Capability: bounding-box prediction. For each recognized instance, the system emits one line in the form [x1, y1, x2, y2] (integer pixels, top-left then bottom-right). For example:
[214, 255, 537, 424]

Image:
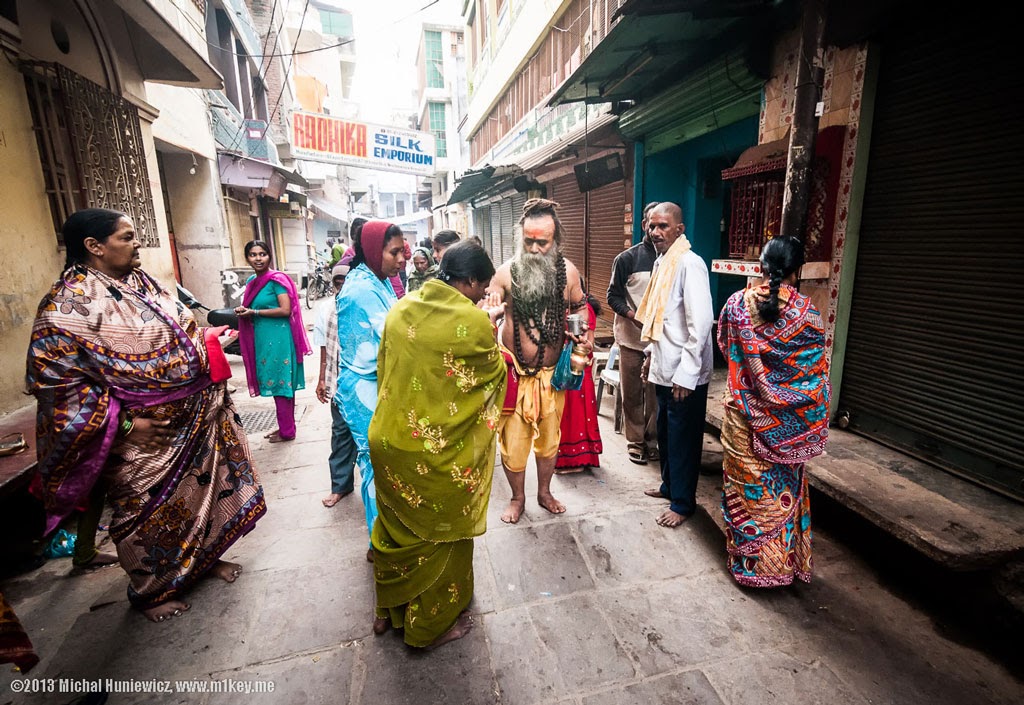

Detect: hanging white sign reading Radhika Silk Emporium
[292, 111, 436, 175]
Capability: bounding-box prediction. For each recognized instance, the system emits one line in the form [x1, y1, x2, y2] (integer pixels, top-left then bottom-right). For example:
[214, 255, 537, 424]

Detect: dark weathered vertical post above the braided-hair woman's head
[779, 0, 827, 240]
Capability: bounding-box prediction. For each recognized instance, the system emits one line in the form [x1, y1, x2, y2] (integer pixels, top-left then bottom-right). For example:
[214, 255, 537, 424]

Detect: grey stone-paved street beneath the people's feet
[0, 363, 1024, 705]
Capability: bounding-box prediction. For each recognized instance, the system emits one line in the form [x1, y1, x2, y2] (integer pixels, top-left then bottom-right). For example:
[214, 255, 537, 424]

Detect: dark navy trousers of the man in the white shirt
[655, 384, 708, 516]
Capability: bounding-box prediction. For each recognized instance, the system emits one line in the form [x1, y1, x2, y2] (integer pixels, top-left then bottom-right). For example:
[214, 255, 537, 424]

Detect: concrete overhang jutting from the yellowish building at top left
[113, 0, 224, 89]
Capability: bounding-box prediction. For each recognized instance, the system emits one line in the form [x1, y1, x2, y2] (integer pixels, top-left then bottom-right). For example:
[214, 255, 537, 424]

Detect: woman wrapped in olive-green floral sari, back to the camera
[370, 242, 507, 647]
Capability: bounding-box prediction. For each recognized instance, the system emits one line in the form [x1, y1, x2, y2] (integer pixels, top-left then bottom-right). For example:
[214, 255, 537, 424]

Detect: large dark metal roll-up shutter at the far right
[838, 13, 1024, 499]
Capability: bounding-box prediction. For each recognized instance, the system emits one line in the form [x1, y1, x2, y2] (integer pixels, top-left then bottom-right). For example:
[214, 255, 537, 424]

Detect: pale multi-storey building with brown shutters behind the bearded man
[450, 0, 633, 320]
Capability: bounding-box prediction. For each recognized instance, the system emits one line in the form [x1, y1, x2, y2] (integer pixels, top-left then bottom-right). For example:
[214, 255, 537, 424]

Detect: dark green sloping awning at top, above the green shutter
[548, 0, 792, 106]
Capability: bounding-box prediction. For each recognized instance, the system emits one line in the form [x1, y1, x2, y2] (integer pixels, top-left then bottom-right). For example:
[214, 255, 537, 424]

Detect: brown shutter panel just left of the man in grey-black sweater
[585, 181, 629, 321]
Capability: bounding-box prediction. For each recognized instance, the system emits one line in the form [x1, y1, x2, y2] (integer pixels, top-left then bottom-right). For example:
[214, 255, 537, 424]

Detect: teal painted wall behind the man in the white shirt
[634, 116, 758, 314]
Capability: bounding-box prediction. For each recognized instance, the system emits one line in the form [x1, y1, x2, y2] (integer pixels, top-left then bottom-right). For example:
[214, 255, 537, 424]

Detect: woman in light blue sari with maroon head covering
[335, 220, 406, 561]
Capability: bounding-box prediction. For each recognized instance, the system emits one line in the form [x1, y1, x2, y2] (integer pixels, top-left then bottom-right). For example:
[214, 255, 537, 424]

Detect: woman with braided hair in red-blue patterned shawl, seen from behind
[718, 238, 831, 587]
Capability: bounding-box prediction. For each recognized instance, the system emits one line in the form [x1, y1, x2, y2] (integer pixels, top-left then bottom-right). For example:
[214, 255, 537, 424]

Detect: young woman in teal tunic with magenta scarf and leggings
[234, 240, 312, 443]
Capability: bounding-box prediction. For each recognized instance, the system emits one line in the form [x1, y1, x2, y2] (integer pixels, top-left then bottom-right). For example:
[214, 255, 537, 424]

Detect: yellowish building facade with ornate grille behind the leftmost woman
[0, 0, 223, 414]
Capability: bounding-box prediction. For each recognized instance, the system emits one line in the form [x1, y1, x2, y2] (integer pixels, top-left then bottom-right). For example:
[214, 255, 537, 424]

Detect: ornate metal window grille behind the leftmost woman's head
[22, 61, 160, 247]
